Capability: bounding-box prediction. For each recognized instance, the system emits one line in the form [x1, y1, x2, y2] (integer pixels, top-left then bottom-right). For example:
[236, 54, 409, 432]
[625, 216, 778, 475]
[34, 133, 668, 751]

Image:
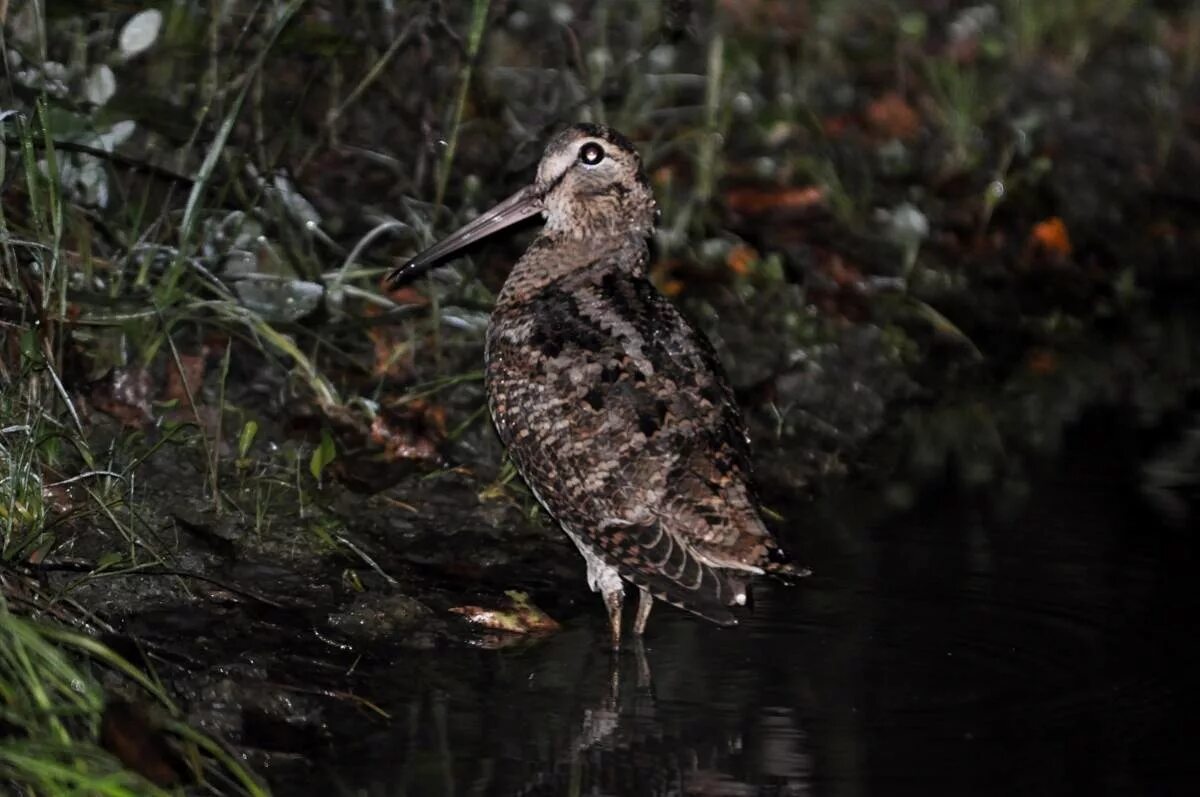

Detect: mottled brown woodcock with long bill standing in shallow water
[389, 125, 806, 648]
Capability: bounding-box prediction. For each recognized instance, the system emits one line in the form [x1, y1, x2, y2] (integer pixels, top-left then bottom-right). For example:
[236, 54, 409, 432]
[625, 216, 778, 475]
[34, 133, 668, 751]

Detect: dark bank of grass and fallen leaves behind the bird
[0, 0, 1200, 795]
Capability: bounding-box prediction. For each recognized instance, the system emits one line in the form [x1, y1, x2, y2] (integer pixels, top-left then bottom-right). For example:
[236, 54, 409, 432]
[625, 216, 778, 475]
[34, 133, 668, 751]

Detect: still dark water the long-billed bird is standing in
[295, 424, 1200, 795]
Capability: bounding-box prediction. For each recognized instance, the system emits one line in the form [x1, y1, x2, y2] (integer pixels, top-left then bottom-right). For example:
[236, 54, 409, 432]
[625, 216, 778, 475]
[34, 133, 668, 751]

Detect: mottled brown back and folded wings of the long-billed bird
[487, 262, 775, 622]
